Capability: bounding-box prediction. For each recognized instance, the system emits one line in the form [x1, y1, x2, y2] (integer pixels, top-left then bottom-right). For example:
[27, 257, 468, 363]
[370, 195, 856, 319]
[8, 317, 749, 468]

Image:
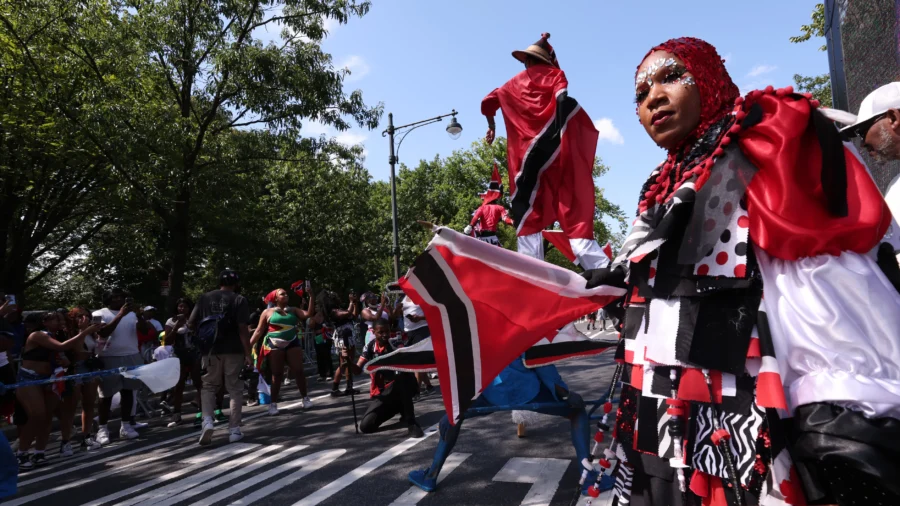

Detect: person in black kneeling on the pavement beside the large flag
[354, 319, 424, 437]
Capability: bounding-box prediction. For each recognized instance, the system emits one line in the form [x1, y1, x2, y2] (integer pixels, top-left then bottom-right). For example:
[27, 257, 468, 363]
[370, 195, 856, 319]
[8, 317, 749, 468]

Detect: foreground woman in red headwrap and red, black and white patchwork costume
[586, 38, 900, 505]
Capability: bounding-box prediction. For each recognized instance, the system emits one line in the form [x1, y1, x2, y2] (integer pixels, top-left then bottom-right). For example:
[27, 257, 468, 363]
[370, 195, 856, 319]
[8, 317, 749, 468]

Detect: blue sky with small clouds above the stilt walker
[286, 0, 828, 214]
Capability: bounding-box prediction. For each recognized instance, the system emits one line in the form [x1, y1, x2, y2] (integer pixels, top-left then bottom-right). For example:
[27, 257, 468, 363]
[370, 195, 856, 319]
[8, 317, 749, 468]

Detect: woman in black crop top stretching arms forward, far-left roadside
[16, 312, 100, 470]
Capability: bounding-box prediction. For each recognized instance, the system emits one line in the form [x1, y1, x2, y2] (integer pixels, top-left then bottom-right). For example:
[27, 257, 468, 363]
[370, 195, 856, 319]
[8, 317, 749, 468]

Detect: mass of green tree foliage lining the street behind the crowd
[0, 0, 625, 311]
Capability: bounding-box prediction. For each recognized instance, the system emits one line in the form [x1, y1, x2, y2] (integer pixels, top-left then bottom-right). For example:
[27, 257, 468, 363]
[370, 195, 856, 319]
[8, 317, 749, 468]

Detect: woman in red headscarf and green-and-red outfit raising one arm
[250, 288, 316, 415]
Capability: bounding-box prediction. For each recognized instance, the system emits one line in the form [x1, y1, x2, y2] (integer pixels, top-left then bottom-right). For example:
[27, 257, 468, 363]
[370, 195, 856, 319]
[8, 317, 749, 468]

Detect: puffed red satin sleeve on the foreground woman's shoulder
[738, 95, 891, 260]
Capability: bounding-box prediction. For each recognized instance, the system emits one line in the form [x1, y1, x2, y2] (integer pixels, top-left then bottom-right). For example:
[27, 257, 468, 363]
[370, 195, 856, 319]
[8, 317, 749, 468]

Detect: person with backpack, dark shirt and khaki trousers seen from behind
[188, 269, 253, 445]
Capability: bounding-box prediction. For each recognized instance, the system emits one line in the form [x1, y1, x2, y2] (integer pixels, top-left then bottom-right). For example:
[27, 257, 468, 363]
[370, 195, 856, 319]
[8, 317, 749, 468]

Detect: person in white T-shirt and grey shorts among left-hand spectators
[93, 288, 147, 445]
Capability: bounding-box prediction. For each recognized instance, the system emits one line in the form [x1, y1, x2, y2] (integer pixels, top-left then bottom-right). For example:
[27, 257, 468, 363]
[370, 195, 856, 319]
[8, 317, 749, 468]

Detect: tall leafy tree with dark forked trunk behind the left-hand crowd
[0, 0, 381, 310]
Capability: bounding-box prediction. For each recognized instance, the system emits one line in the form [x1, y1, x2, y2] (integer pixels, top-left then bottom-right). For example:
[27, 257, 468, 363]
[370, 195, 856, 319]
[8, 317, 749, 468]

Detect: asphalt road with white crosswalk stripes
[10, 324, 614, 506]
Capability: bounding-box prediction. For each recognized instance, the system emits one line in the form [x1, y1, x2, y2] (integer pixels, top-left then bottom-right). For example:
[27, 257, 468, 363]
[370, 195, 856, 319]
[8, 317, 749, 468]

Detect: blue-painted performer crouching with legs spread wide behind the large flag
[409, 359, 612, 492]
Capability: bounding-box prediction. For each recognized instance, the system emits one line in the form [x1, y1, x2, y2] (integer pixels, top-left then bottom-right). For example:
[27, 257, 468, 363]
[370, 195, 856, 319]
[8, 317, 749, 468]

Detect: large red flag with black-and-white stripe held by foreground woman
[400, 227, 625, 423]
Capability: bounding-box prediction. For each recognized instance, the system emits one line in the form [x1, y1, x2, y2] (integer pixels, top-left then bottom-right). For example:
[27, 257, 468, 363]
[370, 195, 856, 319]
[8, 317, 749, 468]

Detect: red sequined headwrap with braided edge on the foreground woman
[635, 37, 740, 211]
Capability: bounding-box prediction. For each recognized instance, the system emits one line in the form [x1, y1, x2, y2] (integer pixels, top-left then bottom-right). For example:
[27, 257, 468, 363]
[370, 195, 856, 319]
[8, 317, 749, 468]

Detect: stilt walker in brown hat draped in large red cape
[481, 33, 609, 269]
